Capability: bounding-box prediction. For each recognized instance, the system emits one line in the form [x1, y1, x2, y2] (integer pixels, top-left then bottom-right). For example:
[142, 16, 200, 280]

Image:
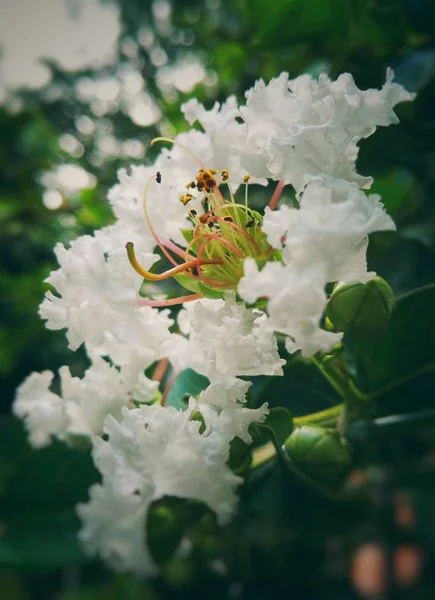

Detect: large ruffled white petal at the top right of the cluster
[240, 69, 415, 192]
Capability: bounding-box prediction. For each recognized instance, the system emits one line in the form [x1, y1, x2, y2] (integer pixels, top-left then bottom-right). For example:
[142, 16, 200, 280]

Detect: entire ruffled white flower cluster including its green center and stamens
[14, 71, 412, 574]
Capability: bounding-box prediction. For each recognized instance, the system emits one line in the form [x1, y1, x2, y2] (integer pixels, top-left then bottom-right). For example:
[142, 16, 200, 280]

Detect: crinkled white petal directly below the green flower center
[165, 292, 285, 381]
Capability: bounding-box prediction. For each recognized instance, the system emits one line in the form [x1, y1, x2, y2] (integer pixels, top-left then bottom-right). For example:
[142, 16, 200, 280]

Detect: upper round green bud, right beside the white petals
[326, 276, 394, 331]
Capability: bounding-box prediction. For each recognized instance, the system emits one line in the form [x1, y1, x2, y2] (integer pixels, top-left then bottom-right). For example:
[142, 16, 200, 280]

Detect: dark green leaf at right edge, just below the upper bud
[344, 284, 435, 394]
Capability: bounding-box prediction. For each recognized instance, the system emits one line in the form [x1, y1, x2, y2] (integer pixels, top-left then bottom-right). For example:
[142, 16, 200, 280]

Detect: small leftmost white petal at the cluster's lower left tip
[12, 371, 67, 448]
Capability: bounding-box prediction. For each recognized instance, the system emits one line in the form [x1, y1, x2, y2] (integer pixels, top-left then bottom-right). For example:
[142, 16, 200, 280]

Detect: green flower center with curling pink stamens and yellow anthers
[126, 139, 276, 299]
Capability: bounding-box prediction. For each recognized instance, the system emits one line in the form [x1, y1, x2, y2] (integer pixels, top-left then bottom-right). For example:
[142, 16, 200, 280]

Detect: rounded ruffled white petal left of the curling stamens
[40, 225, 158, 350]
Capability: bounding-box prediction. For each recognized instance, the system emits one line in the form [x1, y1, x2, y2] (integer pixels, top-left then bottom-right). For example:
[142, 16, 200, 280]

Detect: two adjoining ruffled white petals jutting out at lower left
[13, 356, 158, 447]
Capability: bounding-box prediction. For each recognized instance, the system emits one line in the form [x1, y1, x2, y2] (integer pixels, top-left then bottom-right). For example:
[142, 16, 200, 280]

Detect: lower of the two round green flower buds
[284, 425, 351, 485]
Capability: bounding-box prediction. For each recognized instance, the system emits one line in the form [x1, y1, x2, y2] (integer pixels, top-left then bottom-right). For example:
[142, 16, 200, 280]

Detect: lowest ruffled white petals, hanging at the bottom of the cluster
[78, 405, 242, 575]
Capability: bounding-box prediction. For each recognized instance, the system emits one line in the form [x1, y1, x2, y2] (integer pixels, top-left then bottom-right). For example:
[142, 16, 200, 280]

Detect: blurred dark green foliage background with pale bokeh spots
[0, 0, 435, 600]
